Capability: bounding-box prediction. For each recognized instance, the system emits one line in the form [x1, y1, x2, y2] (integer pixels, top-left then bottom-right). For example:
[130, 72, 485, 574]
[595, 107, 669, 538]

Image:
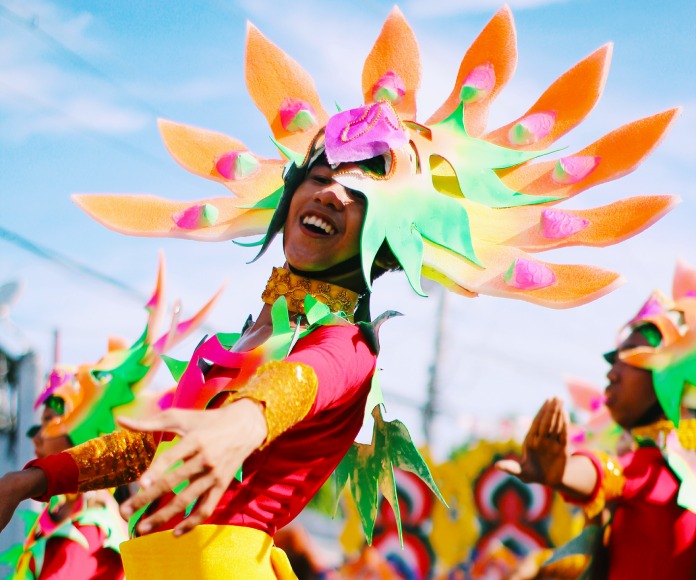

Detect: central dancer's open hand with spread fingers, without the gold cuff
[119, 399, 267, 535]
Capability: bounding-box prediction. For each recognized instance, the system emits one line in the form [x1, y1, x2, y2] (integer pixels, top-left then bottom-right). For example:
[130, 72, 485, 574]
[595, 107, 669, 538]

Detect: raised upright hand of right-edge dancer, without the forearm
[496, 398, 569, 488]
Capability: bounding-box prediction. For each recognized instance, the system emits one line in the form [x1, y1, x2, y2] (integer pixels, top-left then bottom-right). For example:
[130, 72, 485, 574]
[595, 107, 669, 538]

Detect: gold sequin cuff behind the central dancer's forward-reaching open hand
[224, 361, 319, 449]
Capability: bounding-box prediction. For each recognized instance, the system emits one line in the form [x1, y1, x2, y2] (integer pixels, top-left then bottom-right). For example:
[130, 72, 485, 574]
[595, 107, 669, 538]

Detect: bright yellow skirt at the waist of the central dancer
[121, 525, 297, 580]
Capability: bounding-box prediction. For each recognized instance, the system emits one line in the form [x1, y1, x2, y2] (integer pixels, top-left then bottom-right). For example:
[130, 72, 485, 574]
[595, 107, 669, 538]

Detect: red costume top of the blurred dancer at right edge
[582, 447, 696, 580]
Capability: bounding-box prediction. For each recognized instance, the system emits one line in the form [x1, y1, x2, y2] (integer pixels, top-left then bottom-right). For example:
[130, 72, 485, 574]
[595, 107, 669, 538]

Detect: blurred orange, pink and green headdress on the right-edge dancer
[619, 261, 696, 426]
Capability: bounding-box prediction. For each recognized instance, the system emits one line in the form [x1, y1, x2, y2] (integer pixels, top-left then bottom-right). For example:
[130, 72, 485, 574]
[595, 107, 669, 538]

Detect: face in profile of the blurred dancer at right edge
[605, 330, 657, 429]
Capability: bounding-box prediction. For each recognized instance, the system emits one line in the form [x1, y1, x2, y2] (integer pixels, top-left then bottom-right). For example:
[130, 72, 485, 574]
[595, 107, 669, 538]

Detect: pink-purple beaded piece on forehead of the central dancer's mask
[325, 101, 408, 165]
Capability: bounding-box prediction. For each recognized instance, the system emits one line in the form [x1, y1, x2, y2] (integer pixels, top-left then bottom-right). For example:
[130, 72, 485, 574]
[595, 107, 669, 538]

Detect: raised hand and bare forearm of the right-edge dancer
[496, 398, 597, 501]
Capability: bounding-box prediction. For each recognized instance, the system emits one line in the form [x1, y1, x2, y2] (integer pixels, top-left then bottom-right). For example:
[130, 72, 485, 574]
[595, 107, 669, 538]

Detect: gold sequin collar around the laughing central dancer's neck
[261, 268, 358, 314]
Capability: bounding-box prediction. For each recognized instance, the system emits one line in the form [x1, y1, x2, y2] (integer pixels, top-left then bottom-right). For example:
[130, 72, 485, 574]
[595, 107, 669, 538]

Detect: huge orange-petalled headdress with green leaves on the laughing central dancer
[75, 7, 678, 308]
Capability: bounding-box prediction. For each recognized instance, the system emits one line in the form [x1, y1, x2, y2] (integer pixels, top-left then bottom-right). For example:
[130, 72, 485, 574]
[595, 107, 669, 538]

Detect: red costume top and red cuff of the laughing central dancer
[29, 325, 376, 535]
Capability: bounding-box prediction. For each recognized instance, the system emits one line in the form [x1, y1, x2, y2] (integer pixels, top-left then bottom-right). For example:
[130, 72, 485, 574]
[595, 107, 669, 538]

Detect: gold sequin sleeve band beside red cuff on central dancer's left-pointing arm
[66, 431, 156, 492]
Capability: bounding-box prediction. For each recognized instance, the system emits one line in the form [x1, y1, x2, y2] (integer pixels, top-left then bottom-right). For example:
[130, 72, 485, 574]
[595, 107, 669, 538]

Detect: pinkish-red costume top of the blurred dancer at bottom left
[32, 524, 124, 580]
